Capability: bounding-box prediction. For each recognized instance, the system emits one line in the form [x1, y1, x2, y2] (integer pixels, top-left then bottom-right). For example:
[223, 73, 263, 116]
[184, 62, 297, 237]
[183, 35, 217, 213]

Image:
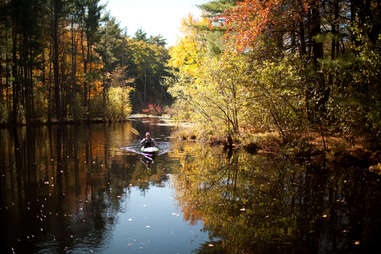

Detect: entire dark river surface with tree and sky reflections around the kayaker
[0, 119, 381, 253]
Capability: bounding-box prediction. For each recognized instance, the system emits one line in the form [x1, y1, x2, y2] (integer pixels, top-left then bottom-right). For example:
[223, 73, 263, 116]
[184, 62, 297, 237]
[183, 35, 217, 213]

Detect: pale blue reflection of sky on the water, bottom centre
[99, 178, 208, 253]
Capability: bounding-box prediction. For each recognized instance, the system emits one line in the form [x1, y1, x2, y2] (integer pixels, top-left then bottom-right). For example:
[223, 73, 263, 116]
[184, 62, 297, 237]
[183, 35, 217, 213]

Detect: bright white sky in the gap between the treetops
[101, 0, 207, 46]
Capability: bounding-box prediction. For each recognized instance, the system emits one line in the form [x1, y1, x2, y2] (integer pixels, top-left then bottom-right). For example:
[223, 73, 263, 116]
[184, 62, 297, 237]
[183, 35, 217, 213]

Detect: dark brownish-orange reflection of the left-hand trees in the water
[0, 124, 171, 253]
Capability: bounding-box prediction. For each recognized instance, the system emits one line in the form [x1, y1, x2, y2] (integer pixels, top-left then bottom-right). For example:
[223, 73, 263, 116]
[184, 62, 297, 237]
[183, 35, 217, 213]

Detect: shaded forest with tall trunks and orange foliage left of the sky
[0, 0, 171, 125]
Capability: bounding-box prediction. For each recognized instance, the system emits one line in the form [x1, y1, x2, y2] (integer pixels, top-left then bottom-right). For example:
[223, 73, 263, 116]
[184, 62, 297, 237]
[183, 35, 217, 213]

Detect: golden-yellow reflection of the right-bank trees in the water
[174, 143, 381, 253]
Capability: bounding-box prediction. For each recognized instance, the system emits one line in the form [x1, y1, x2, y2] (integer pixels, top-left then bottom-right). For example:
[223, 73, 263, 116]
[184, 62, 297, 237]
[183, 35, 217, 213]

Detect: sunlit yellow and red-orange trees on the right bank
[167, 0, 381, 149]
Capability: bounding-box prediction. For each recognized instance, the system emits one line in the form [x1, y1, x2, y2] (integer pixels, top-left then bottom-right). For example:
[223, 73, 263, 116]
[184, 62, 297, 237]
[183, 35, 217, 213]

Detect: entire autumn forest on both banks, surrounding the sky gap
[0, 0, 381, 149]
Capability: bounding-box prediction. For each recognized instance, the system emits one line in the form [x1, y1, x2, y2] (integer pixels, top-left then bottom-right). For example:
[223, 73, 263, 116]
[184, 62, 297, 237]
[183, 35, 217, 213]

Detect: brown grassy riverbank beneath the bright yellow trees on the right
[173, 124, 381, 175]
